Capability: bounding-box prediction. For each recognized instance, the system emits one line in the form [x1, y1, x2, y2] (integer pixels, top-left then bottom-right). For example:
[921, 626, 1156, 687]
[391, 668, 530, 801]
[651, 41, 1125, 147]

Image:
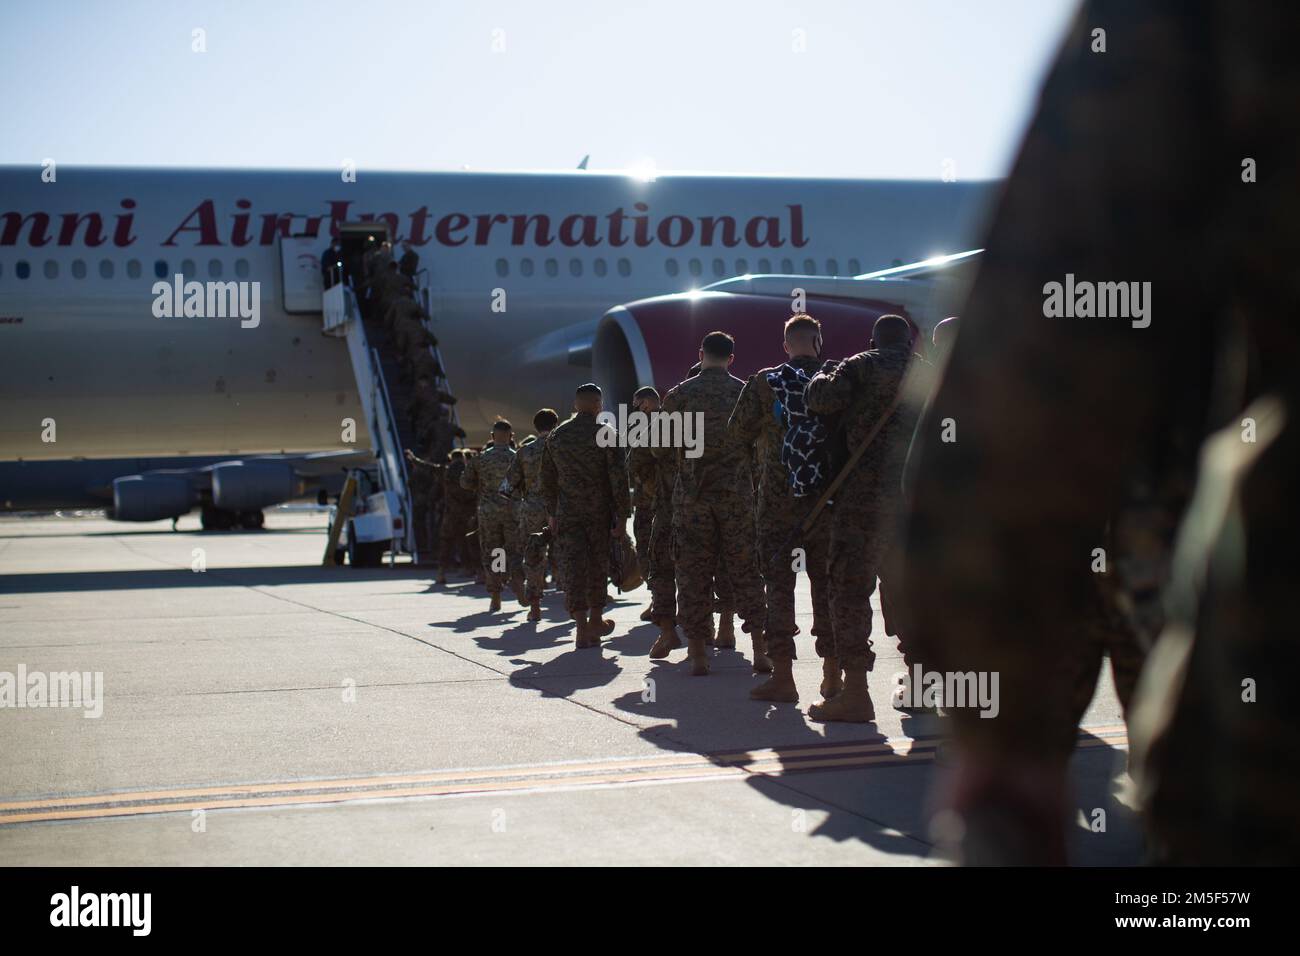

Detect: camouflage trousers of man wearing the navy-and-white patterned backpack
[758, 494, 835, 659]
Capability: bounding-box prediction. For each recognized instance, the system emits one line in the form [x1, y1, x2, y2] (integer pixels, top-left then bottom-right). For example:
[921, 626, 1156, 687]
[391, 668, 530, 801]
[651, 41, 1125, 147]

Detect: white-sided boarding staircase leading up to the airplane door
[321, 271, 459, 562]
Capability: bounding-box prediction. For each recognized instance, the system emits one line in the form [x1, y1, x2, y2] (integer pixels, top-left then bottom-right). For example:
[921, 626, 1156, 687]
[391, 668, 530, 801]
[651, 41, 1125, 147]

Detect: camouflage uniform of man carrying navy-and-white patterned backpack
[727, 358, 835, 658]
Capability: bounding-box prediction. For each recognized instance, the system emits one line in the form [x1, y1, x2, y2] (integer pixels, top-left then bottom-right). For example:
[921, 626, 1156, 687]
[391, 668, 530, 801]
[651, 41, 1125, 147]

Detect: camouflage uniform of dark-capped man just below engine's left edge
[542, 412, 632, 620]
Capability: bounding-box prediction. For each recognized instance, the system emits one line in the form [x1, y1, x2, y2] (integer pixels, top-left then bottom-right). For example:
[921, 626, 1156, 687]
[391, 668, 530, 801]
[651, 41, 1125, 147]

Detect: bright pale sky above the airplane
[0, 0, 1075, 179]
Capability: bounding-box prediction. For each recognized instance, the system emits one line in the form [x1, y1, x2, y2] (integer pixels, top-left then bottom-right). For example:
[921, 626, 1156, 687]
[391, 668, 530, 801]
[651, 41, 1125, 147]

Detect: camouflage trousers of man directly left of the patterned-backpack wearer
[672, 492, 767, 640]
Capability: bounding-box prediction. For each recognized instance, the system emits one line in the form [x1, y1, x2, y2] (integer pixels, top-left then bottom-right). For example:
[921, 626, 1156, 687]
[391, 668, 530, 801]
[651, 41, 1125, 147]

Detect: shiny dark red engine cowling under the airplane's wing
[592, 291, 917, 407]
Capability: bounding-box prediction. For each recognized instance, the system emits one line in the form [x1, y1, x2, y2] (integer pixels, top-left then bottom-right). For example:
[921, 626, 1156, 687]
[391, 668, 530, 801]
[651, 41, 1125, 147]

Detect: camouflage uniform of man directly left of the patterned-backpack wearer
[654, 368, 766, 641]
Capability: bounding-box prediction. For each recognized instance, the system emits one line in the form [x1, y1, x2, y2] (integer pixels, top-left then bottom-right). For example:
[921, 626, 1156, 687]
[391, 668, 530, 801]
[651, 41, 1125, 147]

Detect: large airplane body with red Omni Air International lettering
[0, 166, 997, 520]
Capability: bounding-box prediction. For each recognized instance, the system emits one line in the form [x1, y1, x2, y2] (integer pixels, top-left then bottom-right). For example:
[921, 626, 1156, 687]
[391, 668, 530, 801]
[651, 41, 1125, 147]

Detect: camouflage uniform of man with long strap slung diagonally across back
[805, 343, 924, 671]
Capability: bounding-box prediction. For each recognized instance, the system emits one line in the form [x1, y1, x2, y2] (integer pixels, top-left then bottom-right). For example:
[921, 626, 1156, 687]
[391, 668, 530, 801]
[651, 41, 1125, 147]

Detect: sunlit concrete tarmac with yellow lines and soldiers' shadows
[0, 510, 1141, 866]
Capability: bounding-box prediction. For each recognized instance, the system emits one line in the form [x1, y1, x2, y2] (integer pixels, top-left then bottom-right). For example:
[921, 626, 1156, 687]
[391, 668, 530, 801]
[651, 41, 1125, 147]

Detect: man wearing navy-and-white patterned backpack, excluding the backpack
[727, 315, 840, 702]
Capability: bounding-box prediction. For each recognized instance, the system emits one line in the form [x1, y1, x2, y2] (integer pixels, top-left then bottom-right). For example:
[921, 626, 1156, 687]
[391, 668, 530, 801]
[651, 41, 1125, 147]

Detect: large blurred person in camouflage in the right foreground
[905, 3, 1300, 864]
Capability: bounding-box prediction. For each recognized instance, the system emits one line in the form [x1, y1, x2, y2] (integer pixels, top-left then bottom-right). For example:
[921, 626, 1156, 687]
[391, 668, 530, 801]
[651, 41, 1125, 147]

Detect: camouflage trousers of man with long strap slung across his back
[822, 499, 896, 670]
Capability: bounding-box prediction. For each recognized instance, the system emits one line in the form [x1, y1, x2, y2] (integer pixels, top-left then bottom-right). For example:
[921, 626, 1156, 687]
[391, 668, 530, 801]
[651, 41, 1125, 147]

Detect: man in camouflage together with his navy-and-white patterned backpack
[727, 315, 841, 704]
